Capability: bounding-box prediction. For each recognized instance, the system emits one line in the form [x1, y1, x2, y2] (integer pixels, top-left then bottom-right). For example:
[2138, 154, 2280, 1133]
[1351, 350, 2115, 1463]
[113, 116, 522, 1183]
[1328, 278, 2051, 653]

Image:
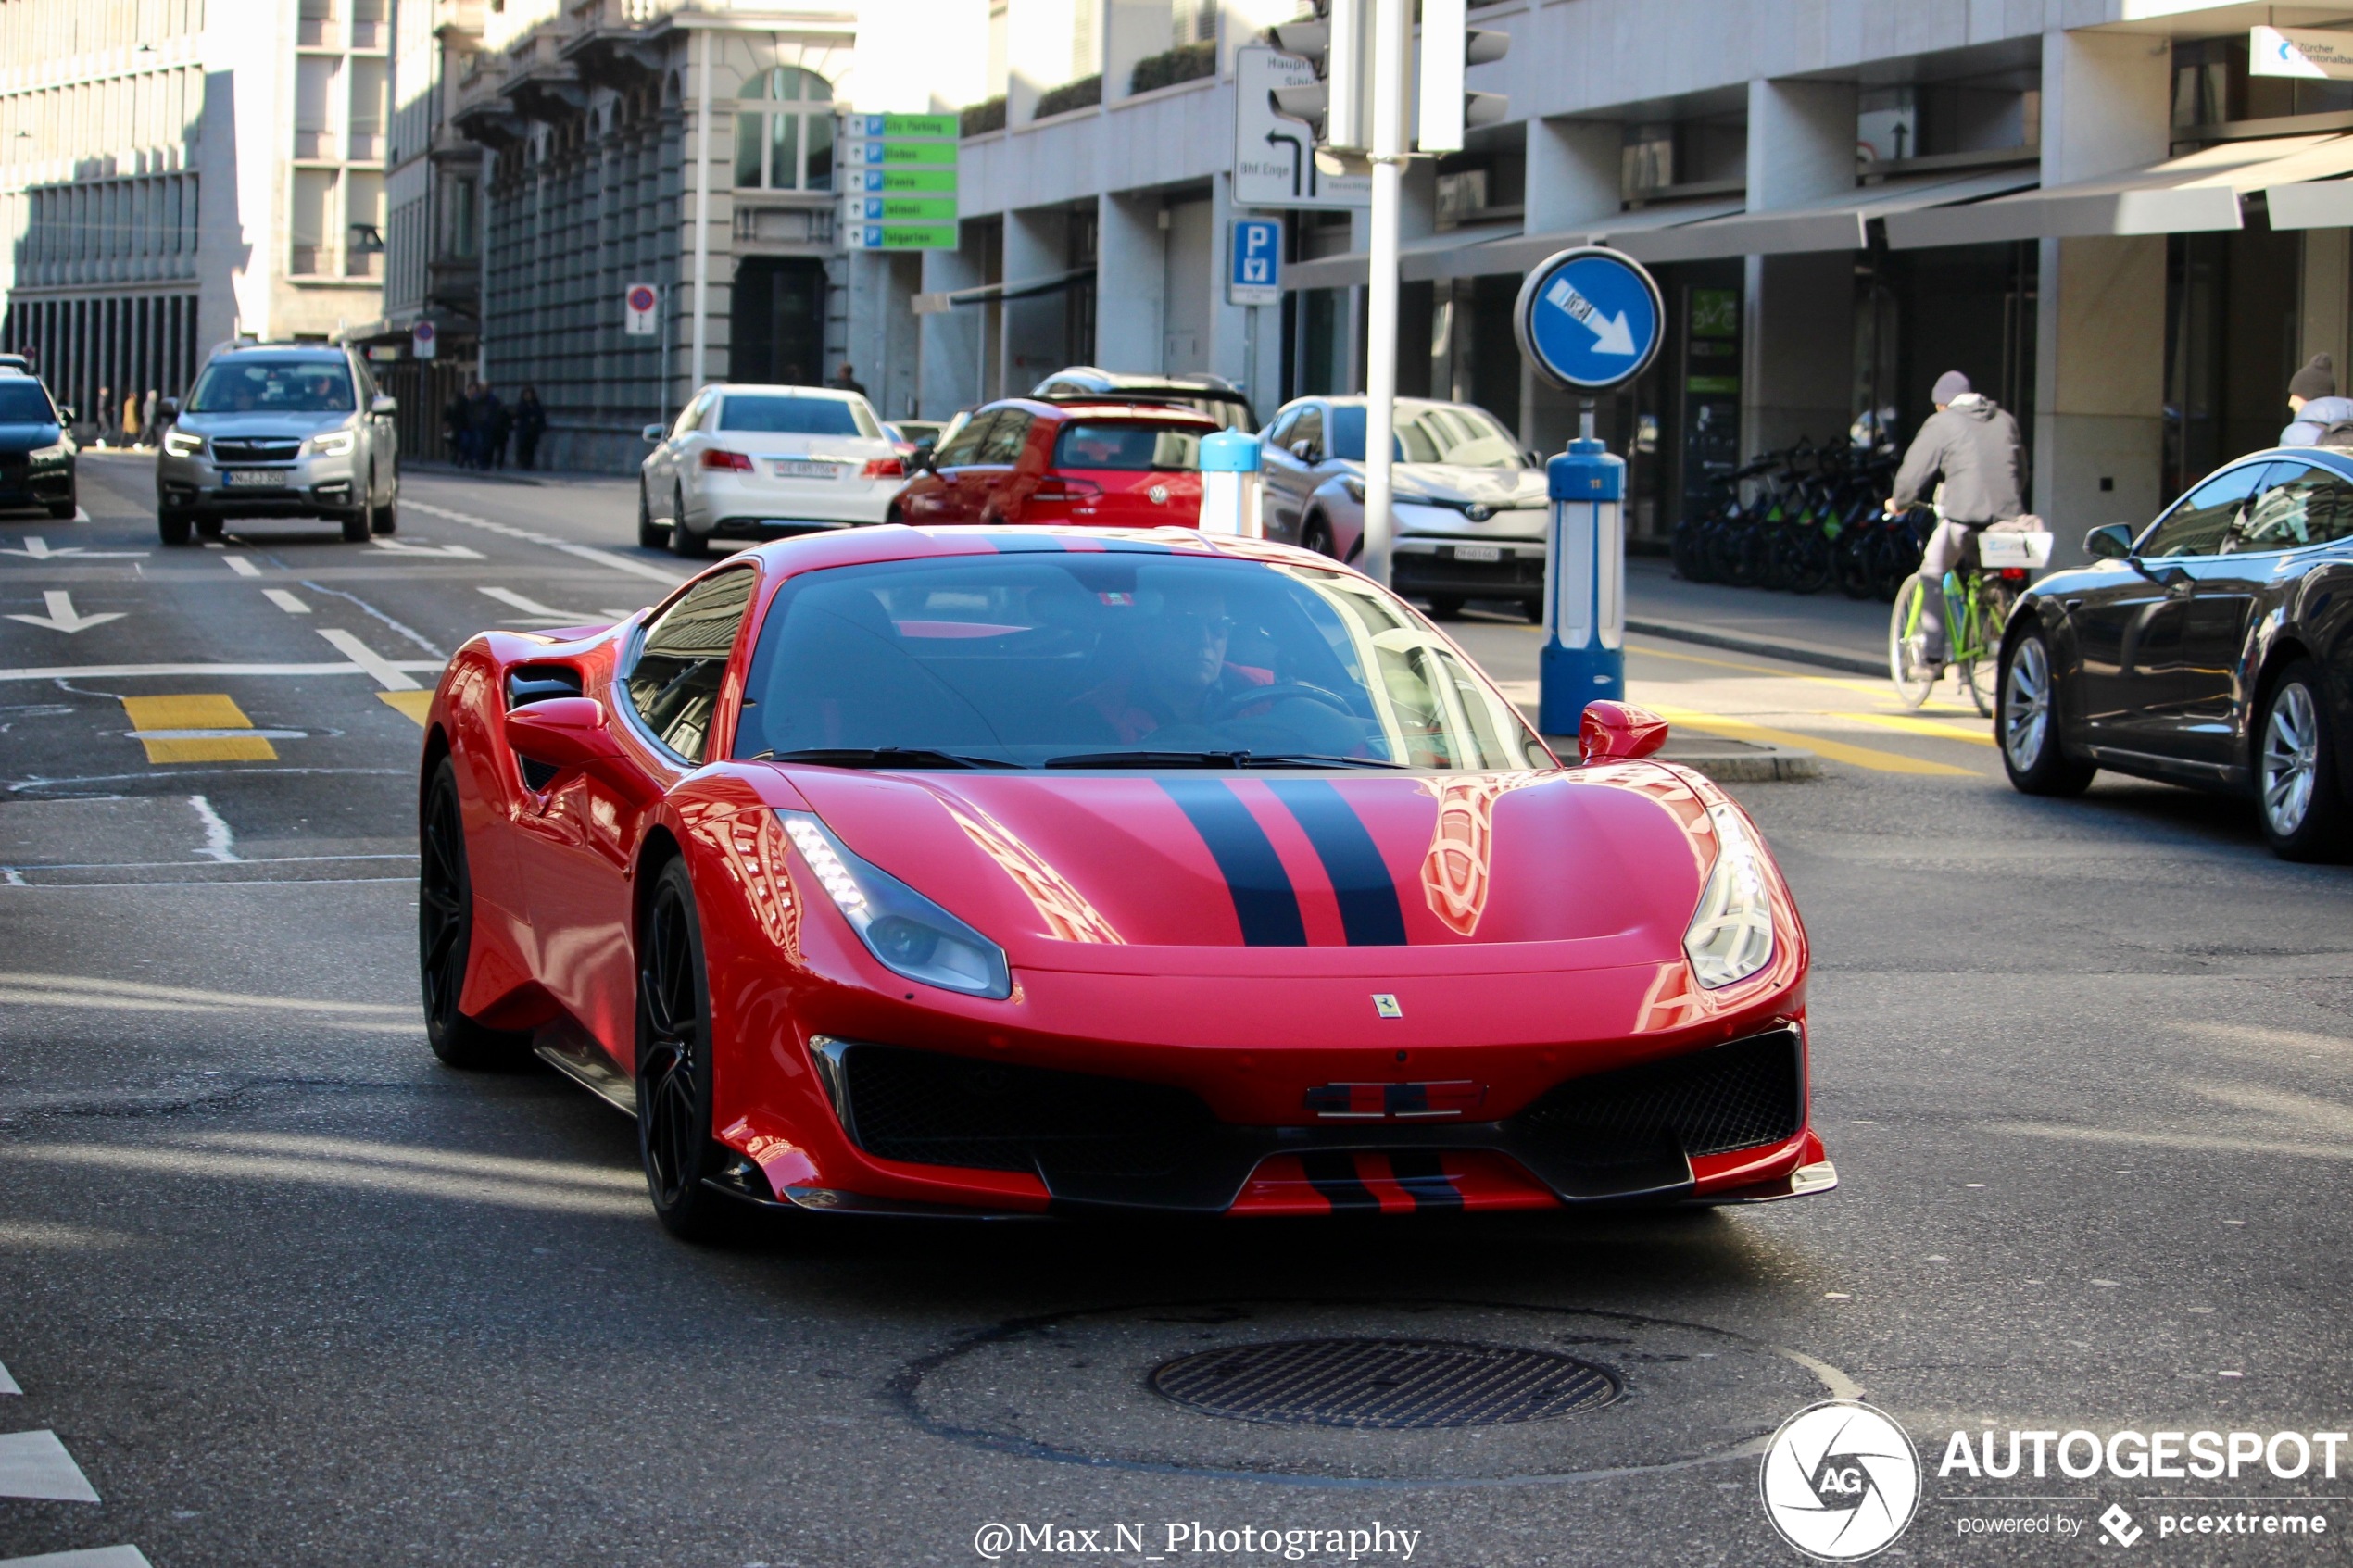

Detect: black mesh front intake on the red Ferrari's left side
[842, 1047, 1216, 1185]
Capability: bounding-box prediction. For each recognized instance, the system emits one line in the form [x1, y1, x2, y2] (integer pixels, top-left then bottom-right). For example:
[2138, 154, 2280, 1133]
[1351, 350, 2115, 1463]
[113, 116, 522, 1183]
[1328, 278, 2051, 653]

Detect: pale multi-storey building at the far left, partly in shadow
[0, 0, 388, 428]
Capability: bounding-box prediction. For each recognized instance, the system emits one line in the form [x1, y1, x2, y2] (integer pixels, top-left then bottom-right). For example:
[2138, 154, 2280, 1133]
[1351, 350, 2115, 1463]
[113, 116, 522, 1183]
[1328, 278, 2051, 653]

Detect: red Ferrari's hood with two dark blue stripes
[788, 761, 1750, 975]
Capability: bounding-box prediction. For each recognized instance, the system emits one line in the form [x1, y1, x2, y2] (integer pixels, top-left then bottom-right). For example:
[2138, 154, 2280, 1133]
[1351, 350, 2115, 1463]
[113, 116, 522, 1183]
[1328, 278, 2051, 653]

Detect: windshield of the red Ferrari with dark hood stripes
[734, 550, 1551, 771]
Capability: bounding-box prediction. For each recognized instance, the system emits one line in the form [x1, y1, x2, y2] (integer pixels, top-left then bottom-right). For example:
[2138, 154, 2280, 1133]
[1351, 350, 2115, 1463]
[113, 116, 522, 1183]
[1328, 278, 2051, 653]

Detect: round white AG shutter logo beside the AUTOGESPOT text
[1757, 1399, 1920, 1563]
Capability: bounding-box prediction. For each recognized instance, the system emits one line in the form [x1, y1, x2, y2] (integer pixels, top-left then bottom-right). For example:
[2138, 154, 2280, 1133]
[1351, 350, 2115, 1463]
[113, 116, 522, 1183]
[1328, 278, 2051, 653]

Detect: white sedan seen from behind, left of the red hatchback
[637, 383, 906, 558]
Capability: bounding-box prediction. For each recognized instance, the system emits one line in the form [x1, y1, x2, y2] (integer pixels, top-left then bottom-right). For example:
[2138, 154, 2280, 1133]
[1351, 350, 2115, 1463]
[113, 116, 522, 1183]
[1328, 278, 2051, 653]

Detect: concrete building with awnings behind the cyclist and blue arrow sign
[923, 0, 2353, 564]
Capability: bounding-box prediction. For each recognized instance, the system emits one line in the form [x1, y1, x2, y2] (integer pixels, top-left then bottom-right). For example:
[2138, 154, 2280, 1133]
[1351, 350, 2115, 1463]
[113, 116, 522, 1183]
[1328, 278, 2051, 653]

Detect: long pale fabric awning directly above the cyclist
[1887, 136, 2353, 252]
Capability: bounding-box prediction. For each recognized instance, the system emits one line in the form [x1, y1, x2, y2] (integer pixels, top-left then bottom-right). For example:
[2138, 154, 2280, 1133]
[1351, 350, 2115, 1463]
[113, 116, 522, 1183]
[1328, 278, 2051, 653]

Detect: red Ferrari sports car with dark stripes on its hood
[419, 527, 1835, 1235]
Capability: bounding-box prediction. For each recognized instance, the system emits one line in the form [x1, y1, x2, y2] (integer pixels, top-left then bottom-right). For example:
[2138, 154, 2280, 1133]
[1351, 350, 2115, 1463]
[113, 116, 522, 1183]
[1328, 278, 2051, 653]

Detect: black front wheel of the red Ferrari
[637, 860, 734, 1241]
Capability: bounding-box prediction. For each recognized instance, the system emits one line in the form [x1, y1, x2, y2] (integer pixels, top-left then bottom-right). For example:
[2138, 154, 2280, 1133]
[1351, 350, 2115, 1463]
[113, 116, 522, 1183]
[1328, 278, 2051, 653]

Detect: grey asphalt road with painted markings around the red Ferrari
[0, 458, 2353, 1568]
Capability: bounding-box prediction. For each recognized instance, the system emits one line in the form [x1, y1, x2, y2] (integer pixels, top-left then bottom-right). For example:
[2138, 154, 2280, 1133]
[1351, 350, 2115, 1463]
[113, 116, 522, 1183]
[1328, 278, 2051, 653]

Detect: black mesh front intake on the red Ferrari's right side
[1513, 1030, 1805, 1159]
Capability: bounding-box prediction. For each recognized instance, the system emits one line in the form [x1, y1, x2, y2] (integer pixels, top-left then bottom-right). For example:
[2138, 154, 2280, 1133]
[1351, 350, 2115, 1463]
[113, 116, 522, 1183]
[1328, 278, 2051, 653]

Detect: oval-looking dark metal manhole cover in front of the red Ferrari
[1153, 1340, 1619, 1432]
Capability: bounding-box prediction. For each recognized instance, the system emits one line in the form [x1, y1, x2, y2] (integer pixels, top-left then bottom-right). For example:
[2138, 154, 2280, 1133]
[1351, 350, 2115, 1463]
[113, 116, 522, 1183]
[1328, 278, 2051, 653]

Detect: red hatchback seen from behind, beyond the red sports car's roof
[892, 397, 1219, 529]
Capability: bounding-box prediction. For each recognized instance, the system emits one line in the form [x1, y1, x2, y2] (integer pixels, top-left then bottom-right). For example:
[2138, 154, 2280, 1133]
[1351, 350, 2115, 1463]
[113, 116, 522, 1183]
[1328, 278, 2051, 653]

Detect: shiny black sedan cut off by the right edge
[1997, 446, 2353, 860]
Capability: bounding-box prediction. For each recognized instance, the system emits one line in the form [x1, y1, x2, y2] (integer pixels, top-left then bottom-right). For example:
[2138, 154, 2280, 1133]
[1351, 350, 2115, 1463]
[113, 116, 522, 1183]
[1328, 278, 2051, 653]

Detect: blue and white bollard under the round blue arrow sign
[1537, 423, 1626, 735]
